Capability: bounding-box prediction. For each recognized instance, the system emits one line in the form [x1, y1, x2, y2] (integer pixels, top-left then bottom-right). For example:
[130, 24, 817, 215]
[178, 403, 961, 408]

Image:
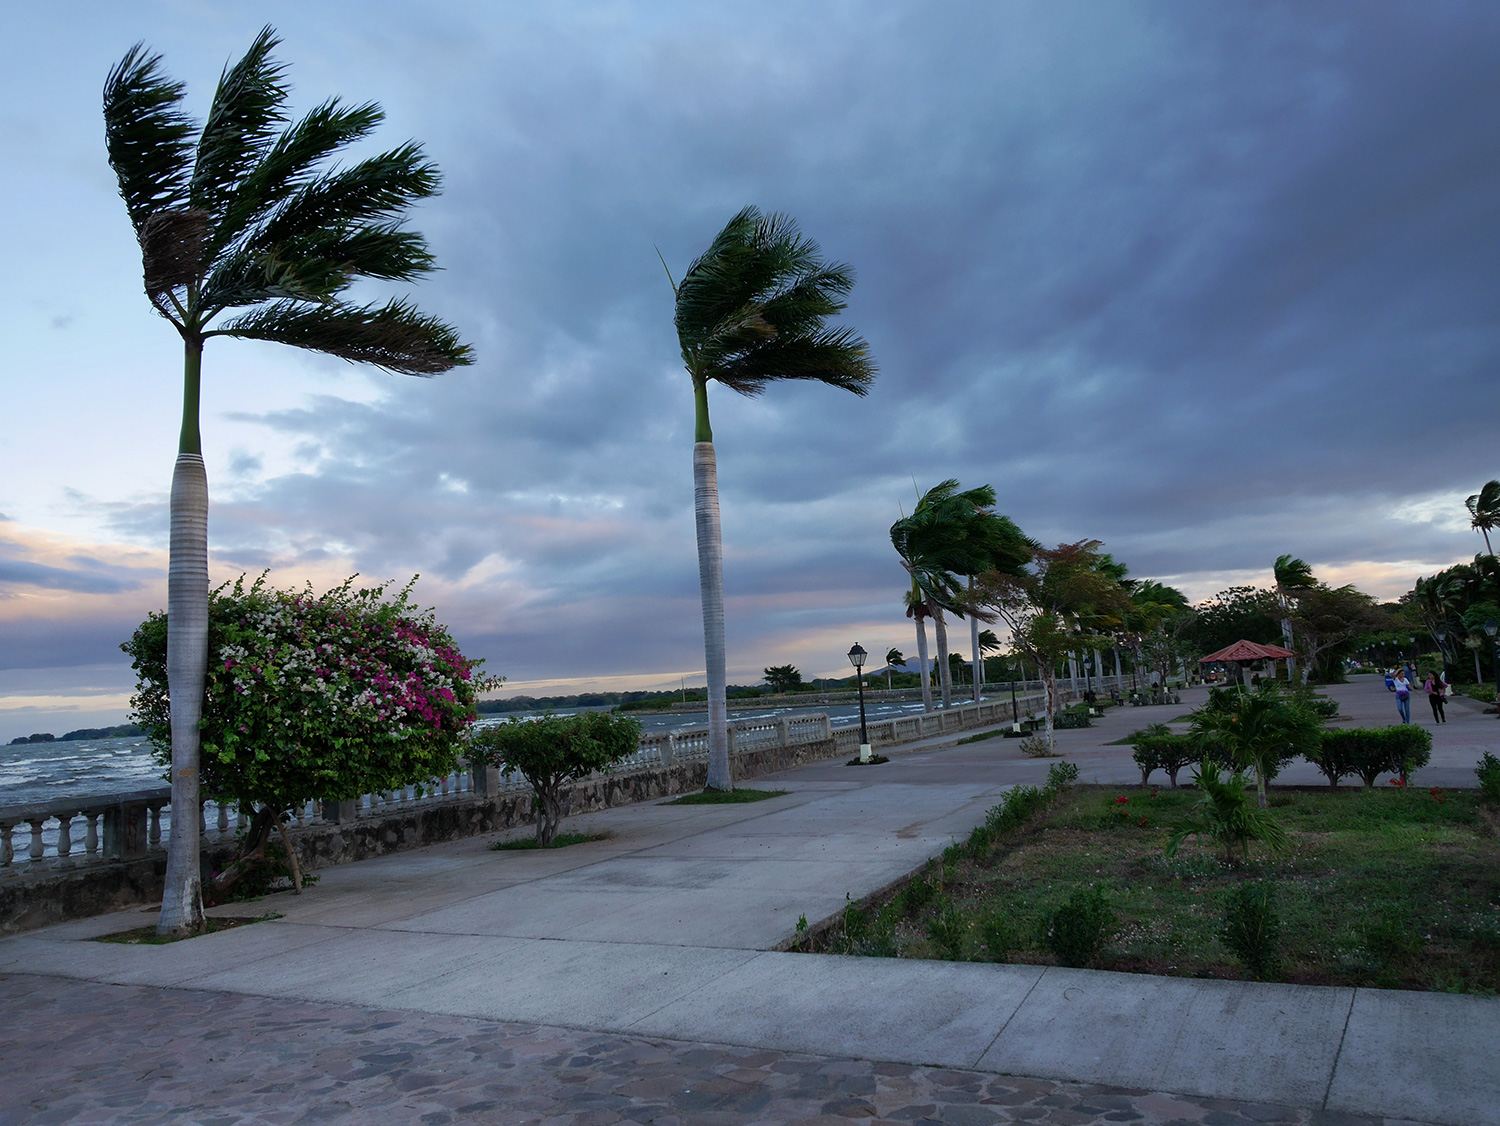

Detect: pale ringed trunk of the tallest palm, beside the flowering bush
[156, 343, 209, 936]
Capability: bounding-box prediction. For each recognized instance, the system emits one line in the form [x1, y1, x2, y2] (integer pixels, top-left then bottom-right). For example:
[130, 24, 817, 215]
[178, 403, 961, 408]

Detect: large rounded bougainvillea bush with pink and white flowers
[120, 576, 498, 891]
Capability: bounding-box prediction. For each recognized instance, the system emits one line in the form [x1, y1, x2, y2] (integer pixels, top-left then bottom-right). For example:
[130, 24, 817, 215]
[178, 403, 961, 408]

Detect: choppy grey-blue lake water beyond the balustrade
[0, 700, 954, 805]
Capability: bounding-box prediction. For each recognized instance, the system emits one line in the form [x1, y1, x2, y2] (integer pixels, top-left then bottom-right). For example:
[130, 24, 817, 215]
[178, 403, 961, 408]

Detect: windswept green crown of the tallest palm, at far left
[105, 27, 471, 375]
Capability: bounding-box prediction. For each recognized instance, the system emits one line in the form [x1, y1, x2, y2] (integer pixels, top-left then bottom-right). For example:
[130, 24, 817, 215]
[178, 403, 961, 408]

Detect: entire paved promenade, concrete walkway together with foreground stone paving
[0, 678, 1500, 1126]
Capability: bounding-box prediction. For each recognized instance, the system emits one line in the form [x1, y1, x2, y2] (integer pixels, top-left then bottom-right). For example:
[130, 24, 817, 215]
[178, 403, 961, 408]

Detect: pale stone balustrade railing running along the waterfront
[0, 676, 1074, 873]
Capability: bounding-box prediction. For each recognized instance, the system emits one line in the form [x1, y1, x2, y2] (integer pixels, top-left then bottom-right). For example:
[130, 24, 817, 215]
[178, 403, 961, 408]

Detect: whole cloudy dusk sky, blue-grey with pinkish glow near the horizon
[0, 0, 1500, 739]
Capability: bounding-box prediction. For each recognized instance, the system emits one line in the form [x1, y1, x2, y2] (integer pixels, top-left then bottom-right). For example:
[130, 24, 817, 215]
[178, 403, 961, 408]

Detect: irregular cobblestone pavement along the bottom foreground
[0, 975, 1416, 1126]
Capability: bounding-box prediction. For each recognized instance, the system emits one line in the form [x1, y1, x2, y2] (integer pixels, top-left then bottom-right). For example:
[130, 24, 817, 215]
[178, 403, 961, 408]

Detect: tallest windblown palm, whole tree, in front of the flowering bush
[104, 27, 471, 934]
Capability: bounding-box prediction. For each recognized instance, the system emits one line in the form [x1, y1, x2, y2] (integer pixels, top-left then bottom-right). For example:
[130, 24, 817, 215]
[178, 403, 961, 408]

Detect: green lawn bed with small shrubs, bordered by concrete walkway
[813, 786, 1500, 993]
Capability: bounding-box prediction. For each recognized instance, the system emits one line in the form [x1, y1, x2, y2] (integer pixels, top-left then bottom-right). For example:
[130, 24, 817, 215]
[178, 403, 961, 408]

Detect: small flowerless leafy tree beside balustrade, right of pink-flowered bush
[471, 712, 641, 849]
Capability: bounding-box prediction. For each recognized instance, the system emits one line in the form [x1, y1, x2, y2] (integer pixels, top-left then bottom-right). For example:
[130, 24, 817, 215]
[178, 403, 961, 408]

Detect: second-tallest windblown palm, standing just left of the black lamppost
[668, 207, 875, 790]
